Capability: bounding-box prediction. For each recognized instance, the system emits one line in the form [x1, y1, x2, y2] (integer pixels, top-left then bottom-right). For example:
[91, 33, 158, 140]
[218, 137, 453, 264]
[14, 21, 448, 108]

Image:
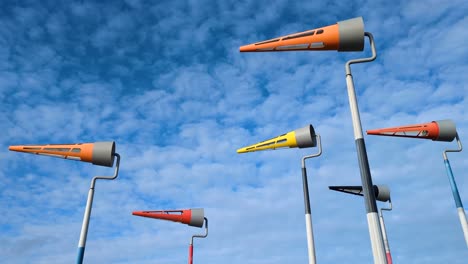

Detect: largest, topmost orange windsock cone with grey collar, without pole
[240, 17, 364, 52]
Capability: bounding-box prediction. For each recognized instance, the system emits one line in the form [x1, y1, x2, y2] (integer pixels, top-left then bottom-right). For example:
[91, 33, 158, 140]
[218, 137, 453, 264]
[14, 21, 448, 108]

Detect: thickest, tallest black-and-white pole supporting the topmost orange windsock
[345, 32, 387, 264]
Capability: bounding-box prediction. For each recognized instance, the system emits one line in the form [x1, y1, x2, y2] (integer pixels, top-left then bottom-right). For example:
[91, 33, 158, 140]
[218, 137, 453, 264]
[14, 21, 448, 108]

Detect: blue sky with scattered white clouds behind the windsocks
[0, 0, 468, 263]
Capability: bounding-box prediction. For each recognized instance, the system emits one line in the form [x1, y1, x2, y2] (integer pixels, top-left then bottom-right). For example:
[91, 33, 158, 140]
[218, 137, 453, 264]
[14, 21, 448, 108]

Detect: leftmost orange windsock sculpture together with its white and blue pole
[9, 141, 120, 264]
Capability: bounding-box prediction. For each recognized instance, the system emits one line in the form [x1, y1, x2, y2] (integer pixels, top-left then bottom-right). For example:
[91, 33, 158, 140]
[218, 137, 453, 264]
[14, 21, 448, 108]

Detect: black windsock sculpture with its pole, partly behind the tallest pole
[328, 185, 393, 264]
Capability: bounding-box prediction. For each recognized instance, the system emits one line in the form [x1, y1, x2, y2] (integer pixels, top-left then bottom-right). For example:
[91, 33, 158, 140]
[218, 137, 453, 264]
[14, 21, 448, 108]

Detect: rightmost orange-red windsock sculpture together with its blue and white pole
[367, 119, 468, 247]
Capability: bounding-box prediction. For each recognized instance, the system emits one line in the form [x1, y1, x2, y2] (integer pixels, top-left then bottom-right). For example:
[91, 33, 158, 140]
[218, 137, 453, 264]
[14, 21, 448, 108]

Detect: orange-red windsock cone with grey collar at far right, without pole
[366, 120, 457, 142]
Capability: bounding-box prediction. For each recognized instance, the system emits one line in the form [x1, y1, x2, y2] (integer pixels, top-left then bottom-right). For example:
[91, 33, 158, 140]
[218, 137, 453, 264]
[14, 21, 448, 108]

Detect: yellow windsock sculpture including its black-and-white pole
[237, 125, 322, 264]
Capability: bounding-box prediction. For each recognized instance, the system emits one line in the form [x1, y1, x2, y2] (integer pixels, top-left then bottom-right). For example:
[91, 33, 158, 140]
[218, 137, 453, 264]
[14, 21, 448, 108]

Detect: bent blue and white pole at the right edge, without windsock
[443, 134, 468, 247]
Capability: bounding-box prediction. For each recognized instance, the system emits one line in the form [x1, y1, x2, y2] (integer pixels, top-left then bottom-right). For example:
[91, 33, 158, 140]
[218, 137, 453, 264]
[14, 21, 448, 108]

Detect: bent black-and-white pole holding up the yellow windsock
[302, 135, 322, 264]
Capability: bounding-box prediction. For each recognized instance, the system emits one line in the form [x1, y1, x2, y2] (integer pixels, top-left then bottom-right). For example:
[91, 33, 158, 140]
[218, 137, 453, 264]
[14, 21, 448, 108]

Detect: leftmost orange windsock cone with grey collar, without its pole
[8, 141, 115, 167]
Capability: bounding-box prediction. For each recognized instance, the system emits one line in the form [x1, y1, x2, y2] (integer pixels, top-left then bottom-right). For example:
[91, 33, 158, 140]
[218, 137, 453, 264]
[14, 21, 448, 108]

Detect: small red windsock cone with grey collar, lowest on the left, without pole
[132, 208, 205, 227]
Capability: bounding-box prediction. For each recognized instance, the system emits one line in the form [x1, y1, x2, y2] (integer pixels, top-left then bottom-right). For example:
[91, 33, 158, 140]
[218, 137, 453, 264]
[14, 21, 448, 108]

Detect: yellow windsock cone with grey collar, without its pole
[237, 125, 317, 153]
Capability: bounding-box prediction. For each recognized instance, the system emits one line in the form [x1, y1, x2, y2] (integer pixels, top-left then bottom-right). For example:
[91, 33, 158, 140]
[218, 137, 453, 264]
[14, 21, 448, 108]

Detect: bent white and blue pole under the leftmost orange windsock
[76, 153, 120, 264]
